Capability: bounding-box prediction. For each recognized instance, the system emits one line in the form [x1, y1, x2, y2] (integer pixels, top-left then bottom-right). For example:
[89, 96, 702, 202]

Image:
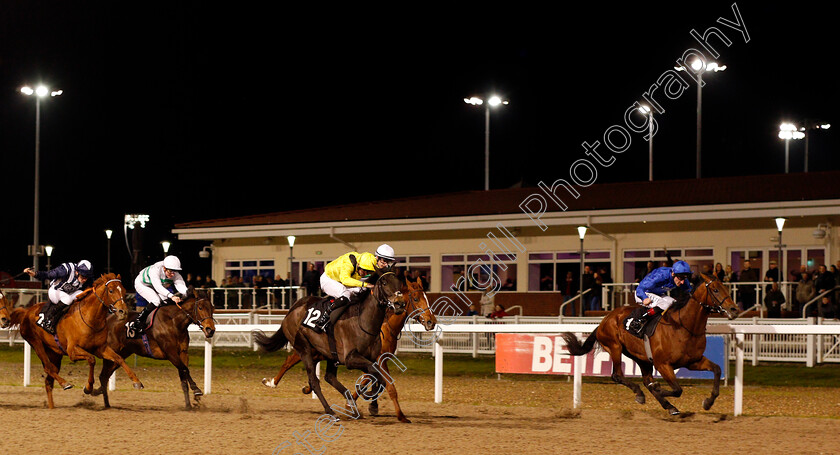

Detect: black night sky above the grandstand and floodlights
[0, 1, 840, 280]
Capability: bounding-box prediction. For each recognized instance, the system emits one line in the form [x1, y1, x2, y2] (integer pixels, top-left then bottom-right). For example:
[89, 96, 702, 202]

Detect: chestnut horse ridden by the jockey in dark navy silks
[0, 273, 143, 409]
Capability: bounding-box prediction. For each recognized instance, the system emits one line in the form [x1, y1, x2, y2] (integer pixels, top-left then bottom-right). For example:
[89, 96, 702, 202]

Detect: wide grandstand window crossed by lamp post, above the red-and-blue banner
[528, 251, 612, 295]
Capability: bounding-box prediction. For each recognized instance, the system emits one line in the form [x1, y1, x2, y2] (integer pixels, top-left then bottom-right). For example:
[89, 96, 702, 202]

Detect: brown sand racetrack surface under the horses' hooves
[0, 362, 840, 455]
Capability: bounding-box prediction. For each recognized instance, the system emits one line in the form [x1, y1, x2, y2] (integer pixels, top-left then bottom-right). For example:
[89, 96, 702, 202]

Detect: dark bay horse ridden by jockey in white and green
[93, 289, 216, 410]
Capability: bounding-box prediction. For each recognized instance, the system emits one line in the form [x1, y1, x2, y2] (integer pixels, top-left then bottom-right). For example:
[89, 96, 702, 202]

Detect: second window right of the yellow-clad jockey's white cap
[440, 254, 517, 292]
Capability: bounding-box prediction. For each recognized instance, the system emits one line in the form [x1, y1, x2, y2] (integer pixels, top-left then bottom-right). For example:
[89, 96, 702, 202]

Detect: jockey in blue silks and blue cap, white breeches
[629, 261, 694, 333]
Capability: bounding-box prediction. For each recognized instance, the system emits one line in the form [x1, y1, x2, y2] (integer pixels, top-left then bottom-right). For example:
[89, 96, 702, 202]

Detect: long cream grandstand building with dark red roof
[173, 171, 840, 315]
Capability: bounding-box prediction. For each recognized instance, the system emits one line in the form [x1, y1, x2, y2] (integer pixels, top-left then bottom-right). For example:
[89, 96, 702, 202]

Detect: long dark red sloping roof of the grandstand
[176, 171, 840, 229]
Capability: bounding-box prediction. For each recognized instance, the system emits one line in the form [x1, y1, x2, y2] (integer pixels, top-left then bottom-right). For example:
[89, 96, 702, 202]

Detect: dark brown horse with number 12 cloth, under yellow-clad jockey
[253, 271, 406, 416]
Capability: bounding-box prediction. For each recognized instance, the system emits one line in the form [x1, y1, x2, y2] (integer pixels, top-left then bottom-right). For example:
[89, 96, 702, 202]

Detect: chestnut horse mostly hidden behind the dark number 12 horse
[262, 278, 437, 423]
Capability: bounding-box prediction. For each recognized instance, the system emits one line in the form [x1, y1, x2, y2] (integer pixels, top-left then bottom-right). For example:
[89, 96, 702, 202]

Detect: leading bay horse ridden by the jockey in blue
[561, 275, 738, 415]
